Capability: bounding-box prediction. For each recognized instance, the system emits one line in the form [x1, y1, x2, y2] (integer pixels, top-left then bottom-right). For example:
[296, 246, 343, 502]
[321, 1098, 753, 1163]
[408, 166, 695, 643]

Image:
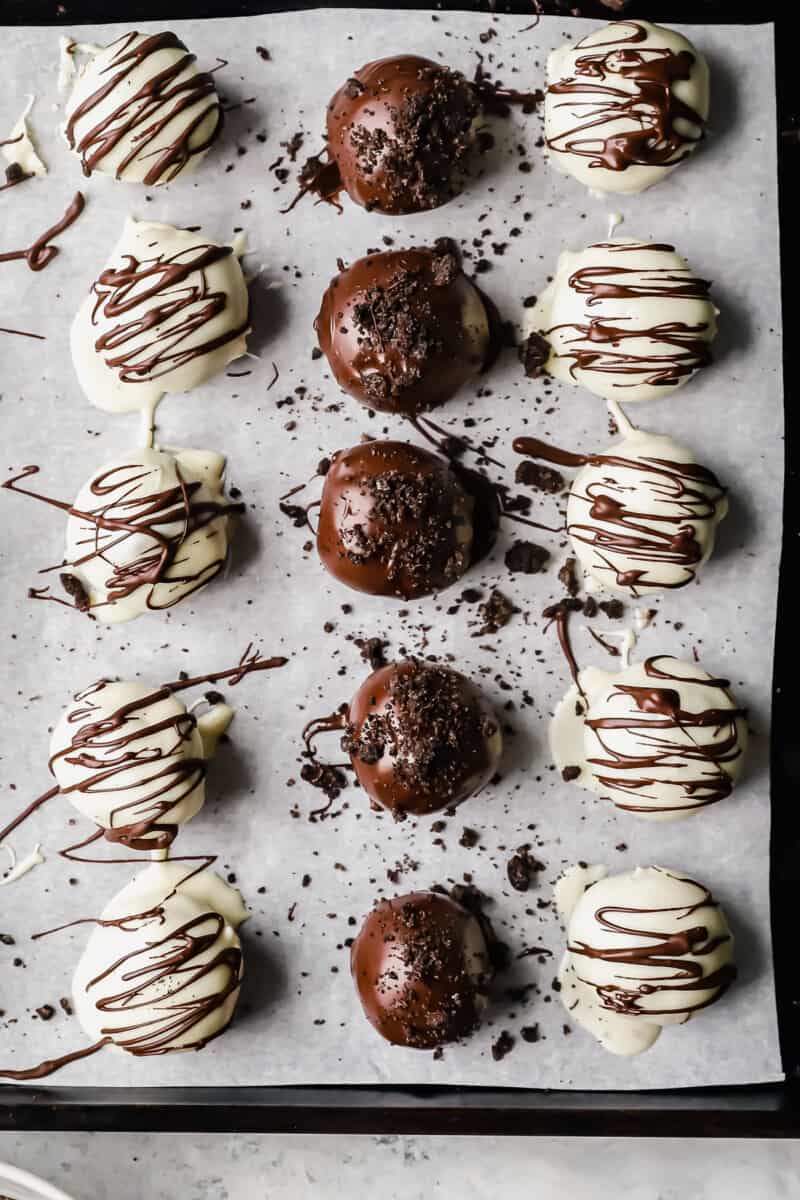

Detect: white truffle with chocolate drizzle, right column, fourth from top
[551, 655, 747, 821]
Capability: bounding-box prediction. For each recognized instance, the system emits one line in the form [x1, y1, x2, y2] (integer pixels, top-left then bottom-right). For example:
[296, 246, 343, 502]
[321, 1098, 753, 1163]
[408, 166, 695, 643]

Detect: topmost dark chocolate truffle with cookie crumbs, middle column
[327, 54, 479, 214]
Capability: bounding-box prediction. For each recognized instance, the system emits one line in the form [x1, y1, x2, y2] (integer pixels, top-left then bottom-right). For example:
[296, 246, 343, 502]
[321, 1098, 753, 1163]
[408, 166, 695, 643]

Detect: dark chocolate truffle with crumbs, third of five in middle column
[317, 442, 474, 600]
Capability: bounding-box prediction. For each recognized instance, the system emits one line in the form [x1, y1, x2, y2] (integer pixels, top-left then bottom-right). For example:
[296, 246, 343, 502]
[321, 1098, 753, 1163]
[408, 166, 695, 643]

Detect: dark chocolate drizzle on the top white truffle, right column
[547, 20, 705, 172]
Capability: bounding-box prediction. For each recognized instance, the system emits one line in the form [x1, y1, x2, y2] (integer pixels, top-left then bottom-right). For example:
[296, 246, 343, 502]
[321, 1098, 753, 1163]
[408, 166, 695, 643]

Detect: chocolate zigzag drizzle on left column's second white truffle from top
[91, 244, 249, 383]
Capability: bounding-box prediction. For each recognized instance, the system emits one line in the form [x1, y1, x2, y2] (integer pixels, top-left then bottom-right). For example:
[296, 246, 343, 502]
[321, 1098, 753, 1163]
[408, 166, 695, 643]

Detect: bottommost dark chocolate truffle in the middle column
[350, 892, 493, 1050]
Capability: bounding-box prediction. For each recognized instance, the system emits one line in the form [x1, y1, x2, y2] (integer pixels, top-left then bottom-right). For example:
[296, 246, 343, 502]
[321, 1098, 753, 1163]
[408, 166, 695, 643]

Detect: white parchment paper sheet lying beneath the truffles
[0, 10, 782, 1088]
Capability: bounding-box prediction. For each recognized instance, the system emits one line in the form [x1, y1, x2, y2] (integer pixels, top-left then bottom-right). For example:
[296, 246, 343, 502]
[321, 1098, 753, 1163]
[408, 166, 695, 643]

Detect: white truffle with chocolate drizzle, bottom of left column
[73, 862, 247, 1056]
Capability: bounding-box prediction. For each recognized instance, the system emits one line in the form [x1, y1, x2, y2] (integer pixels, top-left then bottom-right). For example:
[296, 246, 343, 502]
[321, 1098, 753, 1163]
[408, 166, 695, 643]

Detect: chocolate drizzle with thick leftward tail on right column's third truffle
[513, 438, 726, 596]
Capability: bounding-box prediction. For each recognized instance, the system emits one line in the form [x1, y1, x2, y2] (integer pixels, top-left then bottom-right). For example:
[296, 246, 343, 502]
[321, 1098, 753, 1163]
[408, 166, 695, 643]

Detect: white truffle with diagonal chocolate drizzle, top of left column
[65, 32, 222, 186]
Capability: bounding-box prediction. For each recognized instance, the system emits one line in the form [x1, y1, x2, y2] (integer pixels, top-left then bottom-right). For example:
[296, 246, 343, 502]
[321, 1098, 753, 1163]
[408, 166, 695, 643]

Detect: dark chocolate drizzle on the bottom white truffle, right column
[567, 880, 736, 1019]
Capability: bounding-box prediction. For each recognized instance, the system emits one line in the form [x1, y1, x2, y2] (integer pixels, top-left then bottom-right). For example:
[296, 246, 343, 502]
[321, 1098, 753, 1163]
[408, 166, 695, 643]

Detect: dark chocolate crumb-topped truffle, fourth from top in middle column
[343, 659, 503, 816]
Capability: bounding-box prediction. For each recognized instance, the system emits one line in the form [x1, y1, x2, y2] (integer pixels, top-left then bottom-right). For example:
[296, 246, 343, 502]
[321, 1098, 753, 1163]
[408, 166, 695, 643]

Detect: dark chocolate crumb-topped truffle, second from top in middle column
[314, 241, 491, 416]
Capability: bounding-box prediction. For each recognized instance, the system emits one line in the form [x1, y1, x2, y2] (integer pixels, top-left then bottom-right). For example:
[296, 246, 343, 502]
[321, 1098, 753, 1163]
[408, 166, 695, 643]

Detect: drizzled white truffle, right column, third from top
[566, 430, 728, 596]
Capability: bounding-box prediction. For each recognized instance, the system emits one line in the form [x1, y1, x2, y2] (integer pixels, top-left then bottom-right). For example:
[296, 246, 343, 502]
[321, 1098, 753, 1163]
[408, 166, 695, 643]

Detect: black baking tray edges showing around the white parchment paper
[0, 0, 800, 1136]
